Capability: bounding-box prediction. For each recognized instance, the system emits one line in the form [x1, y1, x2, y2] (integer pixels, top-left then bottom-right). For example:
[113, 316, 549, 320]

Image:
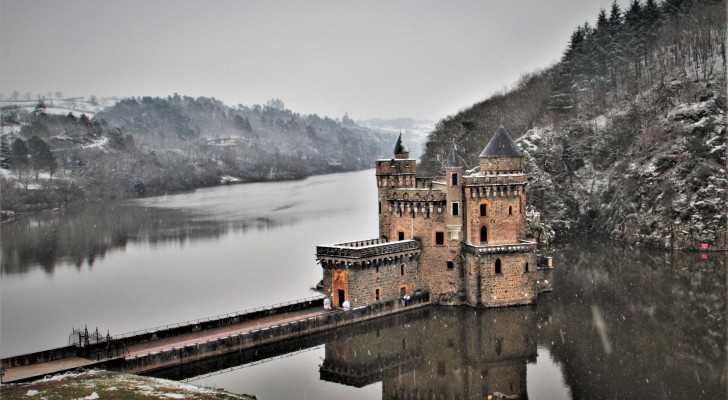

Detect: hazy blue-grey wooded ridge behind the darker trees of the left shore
[97, 95, 393, 173]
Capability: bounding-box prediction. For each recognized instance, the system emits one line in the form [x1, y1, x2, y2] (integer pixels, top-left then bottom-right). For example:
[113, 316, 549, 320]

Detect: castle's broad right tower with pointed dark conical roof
[463, 126, 541, 307]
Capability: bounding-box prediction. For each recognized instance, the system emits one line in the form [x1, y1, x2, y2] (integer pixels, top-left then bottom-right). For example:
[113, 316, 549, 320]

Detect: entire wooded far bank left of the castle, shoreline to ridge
[0, 94, 396, 209]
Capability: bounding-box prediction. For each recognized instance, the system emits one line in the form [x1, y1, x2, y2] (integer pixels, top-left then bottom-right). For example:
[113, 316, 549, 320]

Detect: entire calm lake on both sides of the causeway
[0, 170, 728, 399]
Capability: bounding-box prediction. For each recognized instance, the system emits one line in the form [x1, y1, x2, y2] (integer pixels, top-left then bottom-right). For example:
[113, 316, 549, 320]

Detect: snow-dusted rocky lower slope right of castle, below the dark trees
[517, 81, 728, 249]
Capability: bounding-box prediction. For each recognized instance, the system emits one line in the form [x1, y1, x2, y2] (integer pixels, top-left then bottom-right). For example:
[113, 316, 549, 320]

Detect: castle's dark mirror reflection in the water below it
[320, 307, 537, 400]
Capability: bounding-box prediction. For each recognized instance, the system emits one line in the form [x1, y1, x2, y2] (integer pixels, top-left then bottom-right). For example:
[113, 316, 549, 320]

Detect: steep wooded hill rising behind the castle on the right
[419, 0, 728, 249]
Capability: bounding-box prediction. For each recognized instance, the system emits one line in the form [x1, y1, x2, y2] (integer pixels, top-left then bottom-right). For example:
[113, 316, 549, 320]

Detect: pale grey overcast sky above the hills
[0, 0, 628, 120]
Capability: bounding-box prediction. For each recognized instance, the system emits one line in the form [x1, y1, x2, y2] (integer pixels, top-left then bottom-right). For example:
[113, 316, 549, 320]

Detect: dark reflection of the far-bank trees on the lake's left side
[0, 203, 233, 274]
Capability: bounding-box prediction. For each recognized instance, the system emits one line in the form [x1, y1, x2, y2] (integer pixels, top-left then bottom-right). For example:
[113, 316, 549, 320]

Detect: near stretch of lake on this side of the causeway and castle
[175, 243, 728, 399]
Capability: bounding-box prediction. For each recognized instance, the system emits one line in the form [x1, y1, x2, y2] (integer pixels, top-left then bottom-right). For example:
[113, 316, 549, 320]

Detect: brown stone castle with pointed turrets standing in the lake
[316, 126, 551, 308]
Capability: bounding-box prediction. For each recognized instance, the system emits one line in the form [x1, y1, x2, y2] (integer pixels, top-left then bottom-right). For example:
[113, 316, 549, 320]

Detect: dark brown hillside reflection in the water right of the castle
[539, 243, 728, 399]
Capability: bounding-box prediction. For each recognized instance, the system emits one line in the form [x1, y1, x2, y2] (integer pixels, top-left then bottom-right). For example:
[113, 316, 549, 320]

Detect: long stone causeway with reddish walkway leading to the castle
[2, 292, 430, 383]
